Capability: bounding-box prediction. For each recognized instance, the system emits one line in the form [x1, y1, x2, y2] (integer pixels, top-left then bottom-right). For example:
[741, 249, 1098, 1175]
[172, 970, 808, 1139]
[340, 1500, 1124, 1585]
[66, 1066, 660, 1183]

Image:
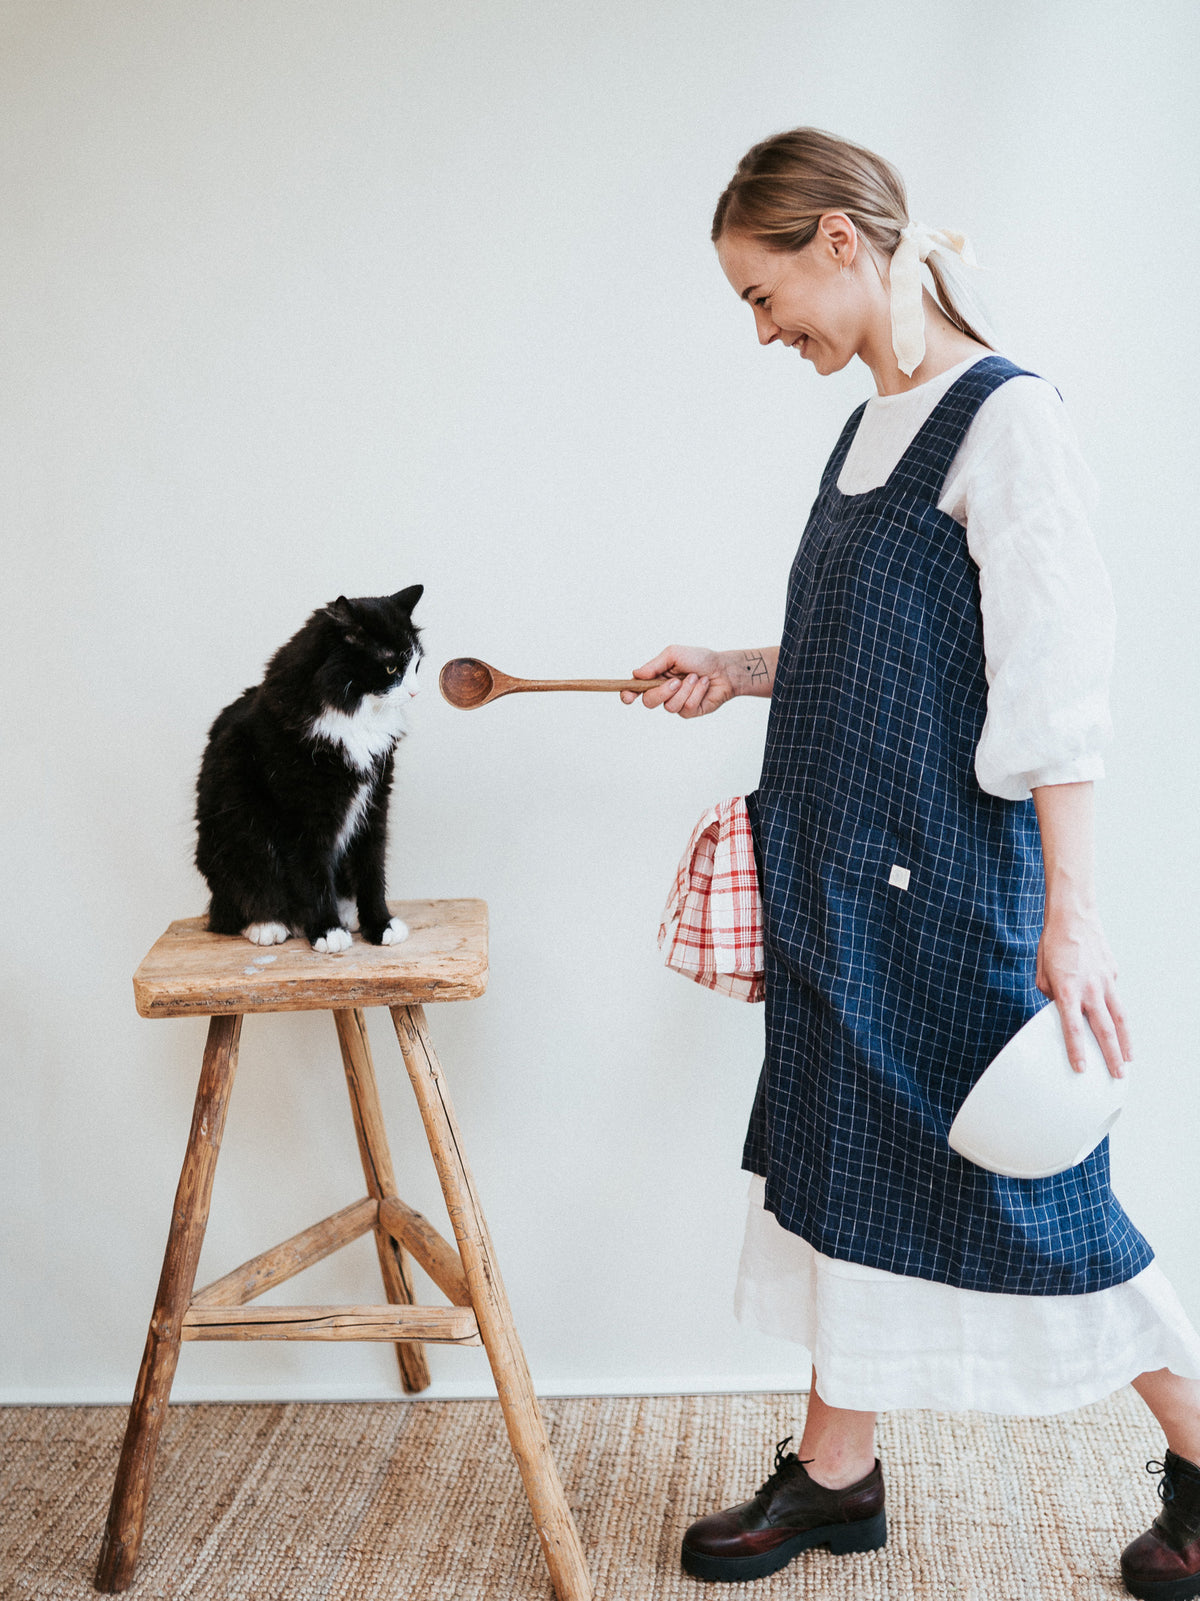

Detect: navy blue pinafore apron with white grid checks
[742, 355, 1154, 1295]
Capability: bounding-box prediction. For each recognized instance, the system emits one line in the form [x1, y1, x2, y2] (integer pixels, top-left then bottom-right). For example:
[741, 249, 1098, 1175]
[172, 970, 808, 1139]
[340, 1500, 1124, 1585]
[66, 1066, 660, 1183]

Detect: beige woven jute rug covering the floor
[0, 1390, 1162, 1601]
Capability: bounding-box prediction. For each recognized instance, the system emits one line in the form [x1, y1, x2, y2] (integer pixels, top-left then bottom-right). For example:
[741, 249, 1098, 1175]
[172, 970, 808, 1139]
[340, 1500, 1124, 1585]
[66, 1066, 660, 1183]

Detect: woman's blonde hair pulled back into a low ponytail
[712, 128, 995, 351]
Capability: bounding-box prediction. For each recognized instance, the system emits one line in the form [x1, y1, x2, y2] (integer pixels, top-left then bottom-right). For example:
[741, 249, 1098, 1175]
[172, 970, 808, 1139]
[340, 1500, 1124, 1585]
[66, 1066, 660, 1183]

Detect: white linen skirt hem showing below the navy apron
[734, 1175, 1200, 1417]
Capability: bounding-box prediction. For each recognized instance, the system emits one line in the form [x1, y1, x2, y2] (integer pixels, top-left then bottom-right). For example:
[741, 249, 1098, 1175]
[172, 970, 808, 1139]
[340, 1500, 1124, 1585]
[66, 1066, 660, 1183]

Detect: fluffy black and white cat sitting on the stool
[195, 584, 424, 951]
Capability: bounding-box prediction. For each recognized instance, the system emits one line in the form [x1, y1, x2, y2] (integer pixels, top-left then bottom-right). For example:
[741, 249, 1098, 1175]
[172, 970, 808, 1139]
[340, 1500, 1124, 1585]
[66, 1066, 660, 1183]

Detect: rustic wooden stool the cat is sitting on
[96, 900, 592, 1601]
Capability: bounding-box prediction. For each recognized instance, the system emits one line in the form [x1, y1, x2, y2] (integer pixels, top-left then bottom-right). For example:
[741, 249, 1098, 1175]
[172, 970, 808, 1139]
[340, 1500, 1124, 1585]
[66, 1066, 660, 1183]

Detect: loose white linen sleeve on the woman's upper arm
[939, 375, 1115, 801]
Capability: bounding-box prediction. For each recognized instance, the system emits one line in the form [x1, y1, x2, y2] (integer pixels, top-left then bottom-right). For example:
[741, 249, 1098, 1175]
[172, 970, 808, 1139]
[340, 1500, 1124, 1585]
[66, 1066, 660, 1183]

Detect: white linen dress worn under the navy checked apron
[734, 355, 1200, 1417]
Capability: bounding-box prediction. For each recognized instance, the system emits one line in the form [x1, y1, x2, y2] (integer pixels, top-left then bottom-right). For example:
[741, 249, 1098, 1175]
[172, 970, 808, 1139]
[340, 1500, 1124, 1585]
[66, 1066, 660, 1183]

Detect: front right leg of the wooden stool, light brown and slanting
[390, 1005, 592, 1601]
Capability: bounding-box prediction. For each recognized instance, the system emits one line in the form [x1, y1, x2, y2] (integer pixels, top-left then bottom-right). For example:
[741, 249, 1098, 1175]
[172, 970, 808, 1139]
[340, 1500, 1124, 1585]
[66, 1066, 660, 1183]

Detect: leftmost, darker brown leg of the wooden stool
[94, 1015, 242, 1590]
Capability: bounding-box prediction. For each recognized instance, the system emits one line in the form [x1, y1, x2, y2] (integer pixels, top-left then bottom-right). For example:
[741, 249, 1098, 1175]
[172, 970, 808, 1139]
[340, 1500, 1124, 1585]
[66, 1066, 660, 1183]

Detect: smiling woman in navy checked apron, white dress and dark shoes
[624, 128, 1200, 1601]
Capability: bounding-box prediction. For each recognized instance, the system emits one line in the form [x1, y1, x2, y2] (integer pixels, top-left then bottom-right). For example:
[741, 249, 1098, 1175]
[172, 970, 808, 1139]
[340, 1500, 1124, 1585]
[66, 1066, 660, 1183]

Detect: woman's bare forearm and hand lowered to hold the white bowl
[1034, 783, 1133, 1079]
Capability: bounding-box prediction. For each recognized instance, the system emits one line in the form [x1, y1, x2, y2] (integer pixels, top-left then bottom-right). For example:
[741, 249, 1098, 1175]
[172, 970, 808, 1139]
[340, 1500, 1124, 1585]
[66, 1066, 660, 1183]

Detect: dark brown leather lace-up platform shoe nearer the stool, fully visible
[683, 1434, 888, 1582]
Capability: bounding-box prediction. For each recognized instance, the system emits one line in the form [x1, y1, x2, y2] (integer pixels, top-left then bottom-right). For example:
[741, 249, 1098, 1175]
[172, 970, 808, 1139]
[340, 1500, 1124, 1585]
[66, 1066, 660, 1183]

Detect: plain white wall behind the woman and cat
[0, 0, 1200, 1399]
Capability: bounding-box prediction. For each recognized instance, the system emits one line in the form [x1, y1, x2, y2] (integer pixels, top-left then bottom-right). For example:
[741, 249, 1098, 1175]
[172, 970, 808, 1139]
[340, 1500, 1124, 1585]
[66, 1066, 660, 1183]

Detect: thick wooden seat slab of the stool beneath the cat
[133, 900, 488, 1017]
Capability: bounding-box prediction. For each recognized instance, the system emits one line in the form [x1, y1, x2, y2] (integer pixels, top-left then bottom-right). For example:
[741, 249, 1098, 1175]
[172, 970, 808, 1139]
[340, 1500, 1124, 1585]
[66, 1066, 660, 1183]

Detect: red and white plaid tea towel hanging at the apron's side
[658, 796, 763, 1001]
